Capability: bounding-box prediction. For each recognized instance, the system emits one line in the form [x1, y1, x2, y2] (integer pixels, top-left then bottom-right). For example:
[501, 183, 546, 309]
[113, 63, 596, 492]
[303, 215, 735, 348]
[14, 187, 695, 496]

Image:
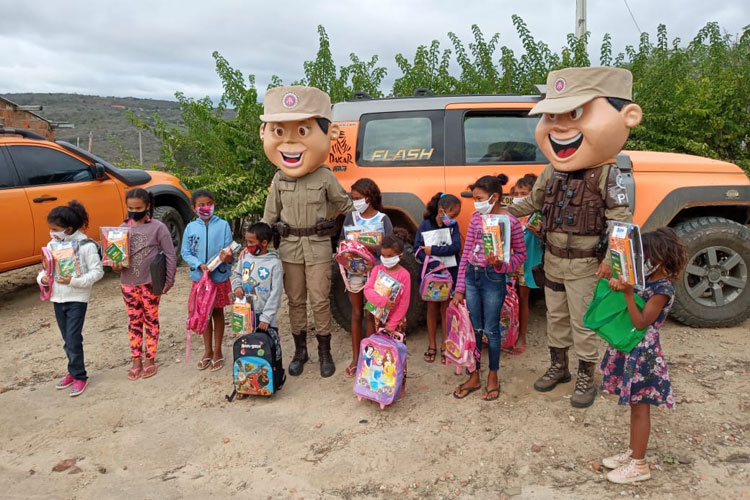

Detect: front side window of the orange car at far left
[9, 146, 94, 186]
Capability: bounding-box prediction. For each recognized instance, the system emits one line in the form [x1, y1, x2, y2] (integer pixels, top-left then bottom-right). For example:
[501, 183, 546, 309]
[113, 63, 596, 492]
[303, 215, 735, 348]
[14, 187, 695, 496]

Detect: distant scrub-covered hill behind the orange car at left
[2, 93, 183, 167]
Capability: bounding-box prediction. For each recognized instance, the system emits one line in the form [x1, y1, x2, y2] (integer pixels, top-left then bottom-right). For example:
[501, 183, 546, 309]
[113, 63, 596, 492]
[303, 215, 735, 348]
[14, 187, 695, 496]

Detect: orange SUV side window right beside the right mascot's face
[464, 112, 547, 165]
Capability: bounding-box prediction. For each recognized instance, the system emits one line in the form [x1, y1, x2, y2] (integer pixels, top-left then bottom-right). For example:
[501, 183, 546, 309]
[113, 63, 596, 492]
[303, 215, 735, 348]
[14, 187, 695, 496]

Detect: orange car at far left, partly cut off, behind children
[0, 128, 193, 272]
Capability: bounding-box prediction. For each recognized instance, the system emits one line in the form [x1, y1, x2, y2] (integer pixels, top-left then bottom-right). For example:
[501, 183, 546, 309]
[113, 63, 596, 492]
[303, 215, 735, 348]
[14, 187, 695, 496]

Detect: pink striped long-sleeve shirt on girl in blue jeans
[456, 212, 526, 293]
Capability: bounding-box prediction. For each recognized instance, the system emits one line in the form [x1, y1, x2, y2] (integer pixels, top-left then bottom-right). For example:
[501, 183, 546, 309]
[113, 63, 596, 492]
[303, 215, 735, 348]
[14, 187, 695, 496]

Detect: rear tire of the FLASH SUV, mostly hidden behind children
[331, 252, 426, 332]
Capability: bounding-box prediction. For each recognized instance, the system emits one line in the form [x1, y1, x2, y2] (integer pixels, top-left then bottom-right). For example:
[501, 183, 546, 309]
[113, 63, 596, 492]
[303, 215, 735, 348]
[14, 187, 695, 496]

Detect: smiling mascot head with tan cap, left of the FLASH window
[260, 85, 339, 178]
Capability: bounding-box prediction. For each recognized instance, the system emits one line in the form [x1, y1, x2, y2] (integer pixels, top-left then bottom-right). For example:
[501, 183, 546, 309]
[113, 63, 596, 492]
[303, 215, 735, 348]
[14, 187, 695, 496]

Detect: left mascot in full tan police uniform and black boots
[260, 86, 354, 377]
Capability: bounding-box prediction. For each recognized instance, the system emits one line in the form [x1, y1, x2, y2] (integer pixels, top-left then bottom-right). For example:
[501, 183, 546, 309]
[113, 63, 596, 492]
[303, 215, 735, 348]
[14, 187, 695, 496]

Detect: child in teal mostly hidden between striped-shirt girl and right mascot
[508, 174, 544, 356]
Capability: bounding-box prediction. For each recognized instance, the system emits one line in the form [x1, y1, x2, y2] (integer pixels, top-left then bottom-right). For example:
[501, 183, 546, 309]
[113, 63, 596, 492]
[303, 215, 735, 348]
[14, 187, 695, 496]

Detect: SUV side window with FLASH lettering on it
[357, 111, 443, 166]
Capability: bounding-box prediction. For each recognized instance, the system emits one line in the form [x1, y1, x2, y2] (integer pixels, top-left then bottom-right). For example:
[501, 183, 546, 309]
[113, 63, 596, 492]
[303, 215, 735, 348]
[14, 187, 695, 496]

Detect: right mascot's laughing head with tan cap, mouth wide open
[529, 68, 643, 172]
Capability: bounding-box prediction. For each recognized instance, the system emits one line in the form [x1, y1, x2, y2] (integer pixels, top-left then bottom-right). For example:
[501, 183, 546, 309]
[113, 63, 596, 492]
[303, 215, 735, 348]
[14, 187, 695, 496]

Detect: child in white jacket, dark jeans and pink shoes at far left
[37, 200, 104, 396]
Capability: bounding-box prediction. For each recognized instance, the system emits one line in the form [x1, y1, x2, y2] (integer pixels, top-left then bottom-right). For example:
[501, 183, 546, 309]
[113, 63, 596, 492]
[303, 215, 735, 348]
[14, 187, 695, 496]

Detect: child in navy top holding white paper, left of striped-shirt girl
[414, 193, 461, 364]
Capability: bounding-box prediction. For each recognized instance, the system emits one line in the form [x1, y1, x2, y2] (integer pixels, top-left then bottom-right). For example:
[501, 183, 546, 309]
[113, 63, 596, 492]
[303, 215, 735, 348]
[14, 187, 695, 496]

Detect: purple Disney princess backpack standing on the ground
[354, 328, 407, 410]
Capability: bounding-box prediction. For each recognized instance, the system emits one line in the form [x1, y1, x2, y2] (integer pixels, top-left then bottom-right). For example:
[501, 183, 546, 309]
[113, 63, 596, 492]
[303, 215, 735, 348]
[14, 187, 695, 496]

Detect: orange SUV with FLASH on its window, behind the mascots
[328, 89, 750, 327]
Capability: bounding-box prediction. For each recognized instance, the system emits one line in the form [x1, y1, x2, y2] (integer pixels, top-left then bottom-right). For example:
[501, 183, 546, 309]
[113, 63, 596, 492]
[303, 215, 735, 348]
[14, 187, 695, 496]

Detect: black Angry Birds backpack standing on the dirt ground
[225, 326, 286, 403]
